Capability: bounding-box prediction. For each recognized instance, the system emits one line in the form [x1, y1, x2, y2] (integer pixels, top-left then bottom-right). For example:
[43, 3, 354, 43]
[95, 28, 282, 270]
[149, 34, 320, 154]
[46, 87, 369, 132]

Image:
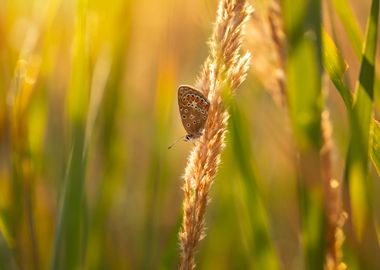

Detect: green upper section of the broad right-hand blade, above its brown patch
[284, 0, 322, 148]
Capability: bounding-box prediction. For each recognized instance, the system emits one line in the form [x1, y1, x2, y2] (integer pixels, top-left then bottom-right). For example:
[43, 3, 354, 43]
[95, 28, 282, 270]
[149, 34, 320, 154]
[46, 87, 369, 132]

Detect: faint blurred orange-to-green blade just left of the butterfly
[140, 61, 178, 269]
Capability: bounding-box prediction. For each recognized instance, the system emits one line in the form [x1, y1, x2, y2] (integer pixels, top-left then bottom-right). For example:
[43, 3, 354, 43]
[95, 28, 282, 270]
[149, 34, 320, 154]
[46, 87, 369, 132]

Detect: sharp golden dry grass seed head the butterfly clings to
[179, 0, 253, 269]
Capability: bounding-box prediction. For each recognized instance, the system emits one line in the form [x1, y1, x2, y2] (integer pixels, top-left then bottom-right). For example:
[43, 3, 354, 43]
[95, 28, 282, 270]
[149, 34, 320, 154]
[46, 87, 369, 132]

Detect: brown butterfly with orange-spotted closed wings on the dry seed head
[169, 85, 210, 149]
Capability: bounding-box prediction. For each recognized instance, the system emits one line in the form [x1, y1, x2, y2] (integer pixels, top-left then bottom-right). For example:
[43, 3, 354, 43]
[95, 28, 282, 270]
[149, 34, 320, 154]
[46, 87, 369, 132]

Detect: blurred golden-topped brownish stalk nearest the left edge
[9, 54, 40, 270]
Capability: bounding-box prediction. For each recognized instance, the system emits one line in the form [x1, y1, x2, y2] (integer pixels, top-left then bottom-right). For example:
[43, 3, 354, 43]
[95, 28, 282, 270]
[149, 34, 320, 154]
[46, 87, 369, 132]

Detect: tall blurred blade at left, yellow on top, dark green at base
[51, 0, 89, 270]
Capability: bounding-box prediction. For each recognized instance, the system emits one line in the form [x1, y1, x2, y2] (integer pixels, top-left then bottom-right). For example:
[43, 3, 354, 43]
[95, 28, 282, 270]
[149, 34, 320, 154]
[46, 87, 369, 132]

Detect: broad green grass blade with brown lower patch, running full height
[283, 0, 325, 269]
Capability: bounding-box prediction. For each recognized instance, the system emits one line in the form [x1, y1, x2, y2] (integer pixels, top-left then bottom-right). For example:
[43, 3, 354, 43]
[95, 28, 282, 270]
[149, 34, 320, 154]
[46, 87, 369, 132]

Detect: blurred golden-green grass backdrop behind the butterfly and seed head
[0, 0, 380, 269]
